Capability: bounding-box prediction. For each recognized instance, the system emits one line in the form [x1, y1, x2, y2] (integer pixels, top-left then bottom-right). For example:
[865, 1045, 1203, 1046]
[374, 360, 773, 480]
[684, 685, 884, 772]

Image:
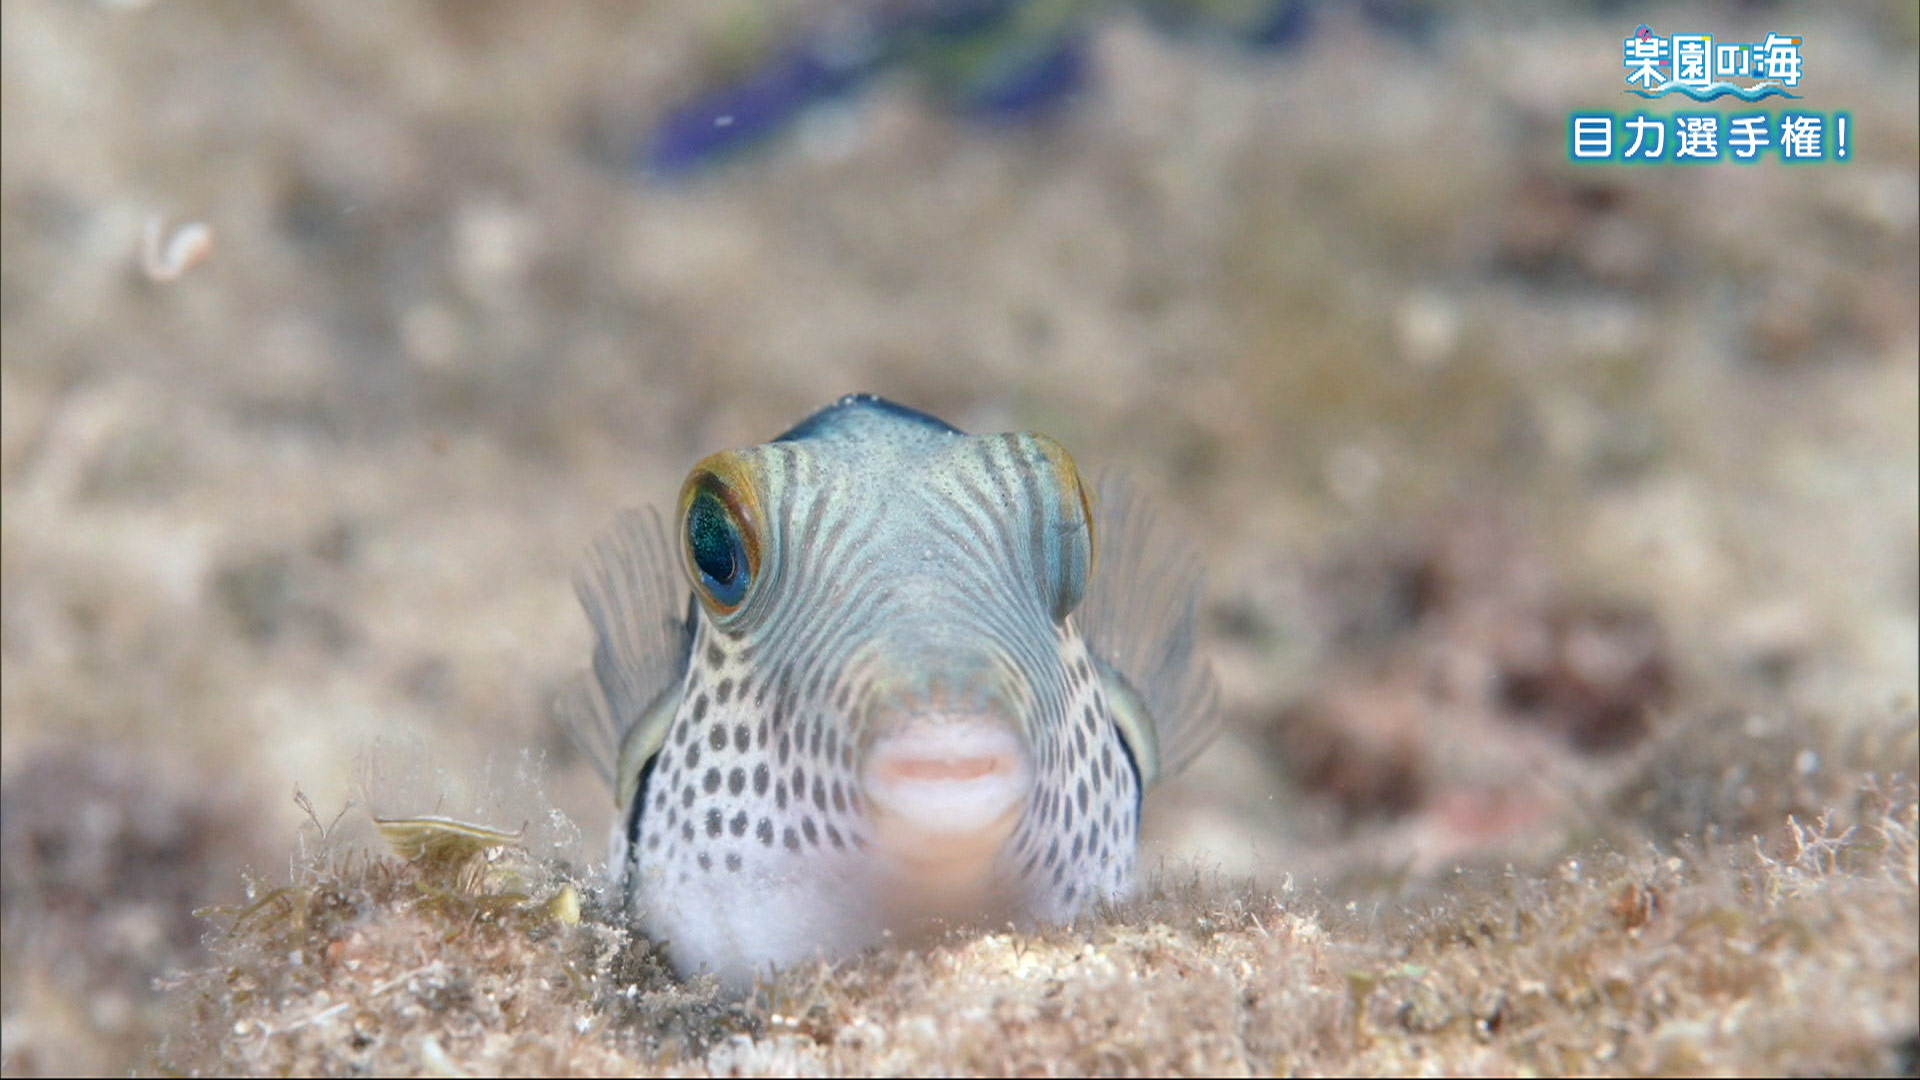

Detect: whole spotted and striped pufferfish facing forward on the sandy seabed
[559, 394, 1215, 986]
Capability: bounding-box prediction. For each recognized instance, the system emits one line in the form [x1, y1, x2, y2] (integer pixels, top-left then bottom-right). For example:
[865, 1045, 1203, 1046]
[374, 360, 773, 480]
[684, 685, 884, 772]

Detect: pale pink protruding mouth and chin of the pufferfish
[860, 717, 1033, 911]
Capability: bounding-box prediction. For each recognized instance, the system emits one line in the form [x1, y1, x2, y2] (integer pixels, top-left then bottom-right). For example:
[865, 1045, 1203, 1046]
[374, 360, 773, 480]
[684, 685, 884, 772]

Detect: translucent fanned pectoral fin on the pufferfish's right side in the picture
[1075, 475, 1219, 786]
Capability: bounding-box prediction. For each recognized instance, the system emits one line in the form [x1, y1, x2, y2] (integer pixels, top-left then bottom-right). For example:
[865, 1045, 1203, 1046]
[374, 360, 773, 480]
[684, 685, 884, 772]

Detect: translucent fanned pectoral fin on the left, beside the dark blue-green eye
[555, 507, 693, 807]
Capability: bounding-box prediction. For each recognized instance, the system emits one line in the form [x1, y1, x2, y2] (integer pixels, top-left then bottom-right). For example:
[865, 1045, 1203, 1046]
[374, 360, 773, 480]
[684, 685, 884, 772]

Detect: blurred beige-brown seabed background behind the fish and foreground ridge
[0, 0, 1920, 1074]
